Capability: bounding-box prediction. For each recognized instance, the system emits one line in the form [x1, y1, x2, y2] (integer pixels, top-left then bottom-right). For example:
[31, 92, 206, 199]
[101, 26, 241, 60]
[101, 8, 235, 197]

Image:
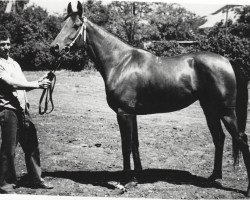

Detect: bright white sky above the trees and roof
[29, 0, 250, 16]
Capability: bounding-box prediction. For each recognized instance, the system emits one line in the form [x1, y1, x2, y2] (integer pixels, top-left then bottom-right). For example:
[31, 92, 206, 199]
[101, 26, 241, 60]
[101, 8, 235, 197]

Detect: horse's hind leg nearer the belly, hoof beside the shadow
[202, 105, 225, 181]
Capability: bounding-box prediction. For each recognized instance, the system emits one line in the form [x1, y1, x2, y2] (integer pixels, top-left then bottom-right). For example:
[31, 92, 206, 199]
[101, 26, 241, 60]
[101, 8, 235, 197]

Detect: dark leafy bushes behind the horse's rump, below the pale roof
[199, 6, 250, 78]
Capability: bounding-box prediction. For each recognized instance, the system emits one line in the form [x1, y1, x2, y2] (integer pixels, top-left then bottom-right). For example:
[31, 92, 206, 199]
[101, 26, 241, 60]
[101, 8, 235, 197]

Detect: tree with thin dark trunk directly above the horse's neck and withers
[106, 1, 152, 46]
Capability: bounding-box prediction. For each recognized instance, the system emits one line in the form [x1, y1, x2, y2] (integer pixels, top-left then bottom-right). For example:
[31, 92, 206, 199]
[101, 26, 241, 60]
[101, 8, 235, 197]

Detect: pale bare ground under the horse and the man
[6, 71, 250, 199]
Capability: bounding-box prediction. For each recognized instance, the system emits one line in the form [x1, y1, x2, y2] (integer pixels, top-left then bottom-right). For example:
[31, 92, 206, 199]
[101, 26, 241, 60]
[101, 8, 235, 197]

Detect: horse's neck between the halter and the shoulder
[87, 21, 132, 79]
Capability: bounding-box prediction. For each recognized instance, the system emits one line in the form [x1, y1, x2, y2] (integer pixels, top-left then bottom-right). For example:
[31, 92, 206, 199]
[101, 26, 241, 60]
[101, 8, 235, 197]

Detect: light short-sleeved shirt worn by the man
[0, 57, 28, 110]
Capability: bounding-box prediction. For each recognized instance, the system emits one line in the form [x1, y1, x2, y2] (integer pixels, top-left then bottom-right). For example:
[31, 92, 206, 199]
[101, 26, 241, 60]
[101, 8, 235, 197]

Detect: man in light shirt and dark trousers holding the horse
[0, 26, 53, 193]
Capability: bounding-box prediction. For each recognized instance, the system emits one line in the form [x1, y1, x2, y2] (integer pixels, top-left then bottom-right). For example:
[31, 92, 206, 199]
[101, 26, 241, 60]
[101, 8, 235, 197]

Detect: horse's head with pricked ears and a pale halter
[50, 1, 86, 55]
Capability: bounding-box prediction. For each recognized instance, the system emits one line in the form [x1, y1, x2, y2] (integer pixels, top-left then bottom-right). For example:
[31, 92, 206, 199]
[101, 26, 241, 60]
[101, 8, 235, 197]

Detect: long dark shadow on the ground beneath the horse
[40, 169, 245, 195]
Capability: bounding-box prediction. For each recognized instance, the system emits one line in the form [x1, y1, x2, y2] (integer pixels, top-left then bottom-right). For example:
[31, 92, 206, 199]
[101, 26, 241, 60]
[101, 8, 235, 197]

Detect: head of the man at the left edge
[0, 25, 10, 59]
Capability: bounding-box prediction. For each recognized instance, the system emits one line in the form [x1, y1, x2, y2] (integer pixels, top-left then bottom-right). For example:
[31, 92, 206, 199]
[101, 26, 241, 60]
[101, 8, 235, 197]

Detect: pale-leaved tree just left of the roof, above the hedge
[150, 3, 203, 40]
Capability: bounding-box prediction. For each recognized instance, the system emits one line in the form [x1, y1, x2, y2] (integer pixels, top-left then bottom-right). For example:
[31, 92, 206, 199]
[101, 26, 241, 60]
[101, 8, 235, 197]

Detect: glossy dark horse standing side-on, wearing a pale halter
[51, 2, 250, 196]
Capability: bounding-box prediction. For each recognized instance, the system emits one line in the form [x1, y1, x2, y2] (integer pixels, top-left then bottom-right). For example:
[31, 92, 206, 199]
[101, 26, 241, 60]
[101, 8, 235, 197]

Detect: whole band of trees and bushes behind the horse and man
[0, 0, 250, 74]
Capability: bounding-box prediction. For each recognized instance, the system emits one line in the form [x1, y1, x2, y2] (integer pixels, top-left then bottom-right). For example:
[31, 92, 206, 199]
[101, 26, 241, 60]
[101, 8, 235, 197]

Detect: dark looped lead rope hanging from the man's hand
[39, 59, 62, 115]
